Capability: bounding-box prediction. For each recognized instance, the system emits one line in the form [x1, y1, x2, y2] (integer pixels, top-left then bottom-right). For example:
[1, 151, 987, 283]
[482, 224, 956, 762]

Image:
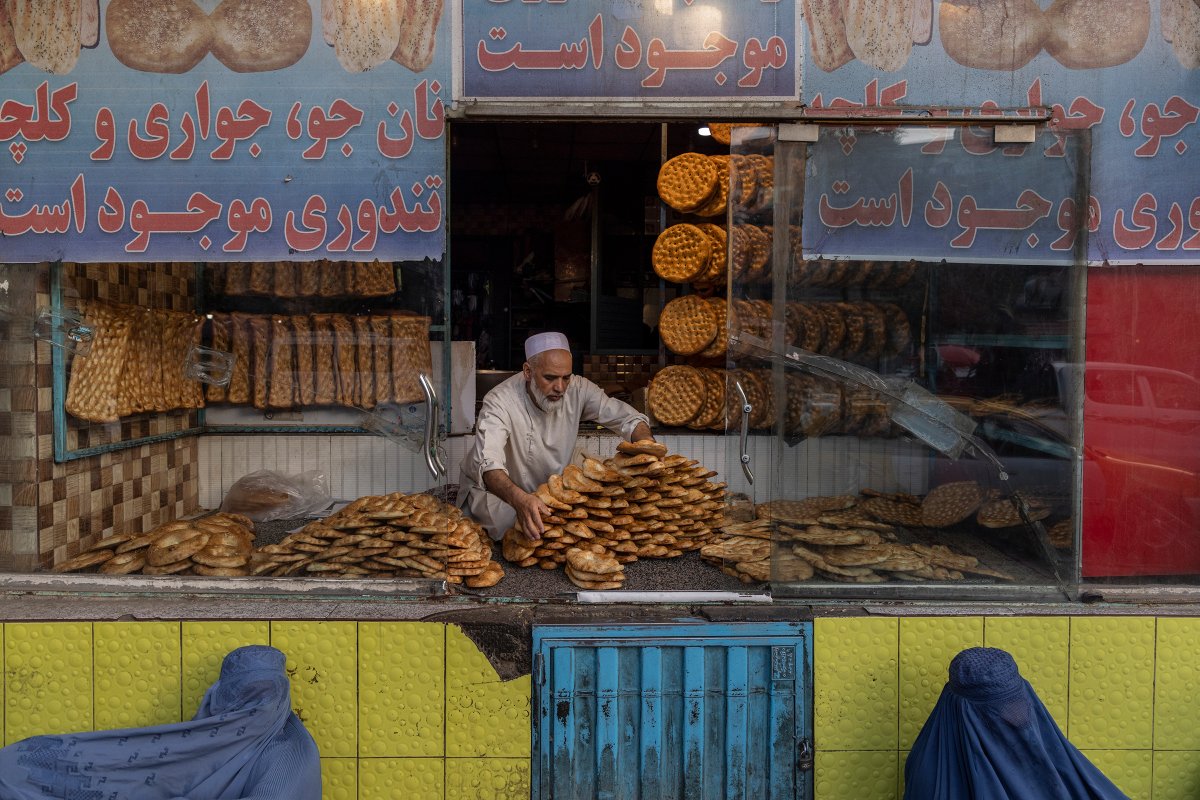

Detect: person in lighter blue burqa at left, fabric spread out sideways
[0, 645, 320, 800]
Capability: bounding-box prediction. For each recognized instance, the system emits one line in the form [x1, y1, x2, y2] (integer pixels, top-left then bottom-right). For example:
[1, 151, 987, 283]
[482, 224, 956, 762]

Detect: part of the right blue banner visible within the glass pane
[800, 126, 1085, 264]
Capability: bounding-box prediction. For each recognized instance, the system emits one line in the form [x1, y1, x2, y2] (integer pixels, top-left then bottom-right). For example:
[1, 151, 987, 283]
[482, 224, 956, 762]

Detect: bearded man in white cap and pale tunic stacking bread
[458, 332, 653, 540]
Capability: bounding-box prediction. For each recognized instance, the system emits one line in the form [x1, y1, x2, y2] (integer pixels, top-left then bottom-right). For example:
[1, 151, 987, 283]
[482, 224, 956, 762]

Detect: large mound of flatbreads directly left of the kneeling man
[251, 492, 504, 589]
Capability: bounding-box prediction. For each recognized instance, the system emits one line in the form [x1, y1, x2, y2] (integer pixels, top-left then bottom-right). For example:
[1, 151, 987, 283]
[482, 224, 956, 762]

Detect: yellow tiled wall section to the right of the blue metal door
[812, 616, 1200, 800]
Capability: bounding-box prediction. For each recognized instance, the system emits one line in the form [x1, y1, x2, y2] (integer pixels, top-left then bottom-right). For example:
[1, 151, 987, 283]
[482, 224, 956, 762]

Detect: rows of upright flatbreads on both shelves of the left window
[65, 261, 433, 423]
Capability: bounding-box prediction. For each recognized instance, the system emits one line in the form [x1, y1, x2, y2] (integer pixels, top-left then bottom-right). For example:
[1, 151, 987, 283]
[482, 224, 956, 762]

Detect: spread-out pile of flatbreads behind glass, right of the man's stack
[701, 489, 1014, 583]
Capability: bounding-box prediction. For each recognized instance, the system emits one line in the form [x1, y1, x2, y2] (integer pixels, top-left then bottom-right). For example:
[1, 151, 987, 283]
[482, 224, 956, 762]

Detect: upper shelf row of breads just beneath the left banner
[208, 260, 396, 299]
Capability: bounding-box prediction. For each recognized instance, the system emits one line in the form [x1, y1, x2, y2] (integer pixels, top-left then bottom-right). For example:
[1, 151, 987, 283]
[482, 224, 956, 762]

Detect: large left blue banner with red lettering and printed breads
[0, 0, 450, 263]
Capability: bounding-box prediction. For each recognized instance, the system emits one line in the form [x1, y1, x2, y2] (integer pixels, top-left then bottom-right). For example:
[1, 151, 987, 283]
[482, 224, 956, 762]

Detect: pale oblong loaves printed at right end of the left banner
[320, 0, 443, 72]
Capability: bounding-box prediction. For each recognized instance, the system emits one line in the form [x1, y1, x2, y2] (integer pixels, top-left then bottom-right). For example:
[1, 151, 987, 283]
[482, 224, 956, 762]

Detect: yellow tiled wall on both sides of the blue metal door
[0, 616, 1200, 800]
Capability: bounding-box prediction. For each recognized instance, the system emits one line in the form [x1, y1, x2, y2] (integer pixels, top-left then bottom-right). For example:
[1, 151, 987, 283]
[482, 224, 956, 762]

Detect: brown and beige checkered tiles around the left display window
[0, 264, 199, 572]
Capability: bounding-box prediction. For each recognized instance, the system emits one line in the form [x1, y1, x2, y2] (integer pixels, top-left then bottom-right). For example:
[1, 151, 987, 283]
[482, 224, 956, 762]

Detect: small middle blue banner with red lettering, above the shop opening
[456, 0, 799, 103]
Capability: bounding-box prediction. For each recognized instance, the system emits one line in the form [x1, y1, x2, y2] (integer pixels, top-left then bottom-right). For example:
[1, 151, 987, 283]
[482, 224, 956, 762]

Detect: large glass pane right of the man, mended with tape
[728, 126, 1082, 596]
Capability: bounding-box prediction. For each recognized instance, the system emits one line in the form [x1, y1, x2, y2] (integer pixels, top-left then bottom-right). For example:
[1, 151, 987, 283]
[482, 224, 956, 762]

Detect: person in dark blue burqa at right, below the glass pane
[905, 648, 1128, 800]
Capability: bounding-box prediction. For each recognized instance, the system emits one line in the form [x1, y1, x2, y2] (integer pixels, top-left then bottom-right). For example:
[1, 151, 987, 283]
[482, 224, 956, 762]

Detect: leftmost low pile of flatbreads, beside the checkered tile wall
[54, 512, 254, 577]
